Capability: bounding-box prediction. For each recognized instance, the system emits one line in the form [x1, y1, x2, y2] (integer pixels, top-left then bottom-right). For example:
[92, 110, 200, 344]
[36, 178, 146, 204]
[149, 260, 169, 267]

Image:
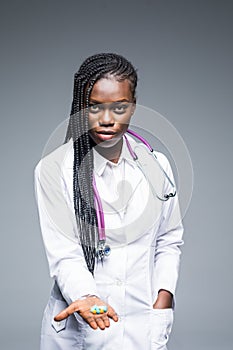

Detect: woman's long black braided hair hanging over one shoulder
[65, 53, 137, 274]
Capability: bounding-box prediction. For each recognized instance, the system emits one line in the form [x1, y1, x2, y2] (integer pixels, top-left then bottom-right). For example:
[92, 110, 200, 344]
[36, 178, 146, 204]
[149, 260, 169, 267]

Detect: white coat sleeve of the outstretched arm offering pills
[34, 157, 97, 304]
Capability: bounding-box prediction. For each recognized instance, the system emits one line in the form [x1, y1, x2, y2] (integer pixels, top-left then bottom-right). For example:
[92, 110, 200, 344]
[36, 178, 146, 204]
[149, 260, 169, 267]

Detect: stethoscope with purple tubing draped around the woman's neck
[93, 129, 176, 261]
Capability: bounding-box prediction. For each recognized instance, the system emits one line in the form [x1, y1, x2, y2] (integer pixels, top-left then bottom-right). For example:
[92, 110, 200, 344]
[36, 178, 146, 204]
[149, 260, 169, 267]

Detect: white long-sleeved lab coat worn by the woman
[35, 136, 183, 350]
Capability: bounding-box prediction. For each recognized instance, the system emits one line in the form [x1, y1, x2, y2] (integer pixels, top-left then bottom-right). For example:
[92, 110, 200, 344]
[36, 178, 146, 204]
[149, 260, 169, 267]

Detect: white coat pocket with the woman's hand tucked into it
[151, 309, 174, 350]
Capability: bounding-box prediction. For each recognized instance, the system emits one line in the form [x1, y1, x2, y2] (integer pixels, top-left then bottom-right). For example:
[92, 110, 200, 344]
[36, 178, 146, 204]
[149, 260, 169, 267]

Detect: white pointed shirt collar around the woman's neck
[93, 135, 136, 176]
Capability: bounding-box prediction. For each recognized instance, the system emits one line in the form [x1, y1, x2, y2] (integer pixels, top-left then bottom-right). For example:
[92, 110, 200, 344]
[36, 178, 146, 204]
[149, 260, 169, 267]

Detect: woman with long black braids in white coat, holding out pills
[35, 53, 183, 350]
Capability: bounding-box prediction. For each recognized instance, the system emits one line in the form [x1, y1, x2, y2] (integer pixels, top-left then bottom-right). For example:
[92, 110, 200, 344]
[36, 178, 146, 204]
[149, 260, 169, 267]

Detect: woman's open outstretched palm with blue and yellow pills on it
[54, 297, 118, 330]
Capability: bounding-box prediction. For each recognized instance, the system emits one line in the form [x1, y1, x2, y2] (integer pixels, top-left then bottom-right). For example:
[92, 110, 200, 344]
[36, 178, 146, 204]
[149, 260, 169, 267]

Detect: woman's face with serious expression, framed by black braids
[89, 77, 135, 147]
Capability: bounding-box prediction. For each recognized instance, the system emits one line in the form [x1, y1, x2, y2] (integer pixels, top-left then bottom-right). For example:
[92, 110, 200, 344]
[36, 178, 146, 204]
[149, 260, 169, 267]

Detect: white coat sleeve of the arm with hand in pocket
[154, 153, 183, 304]
